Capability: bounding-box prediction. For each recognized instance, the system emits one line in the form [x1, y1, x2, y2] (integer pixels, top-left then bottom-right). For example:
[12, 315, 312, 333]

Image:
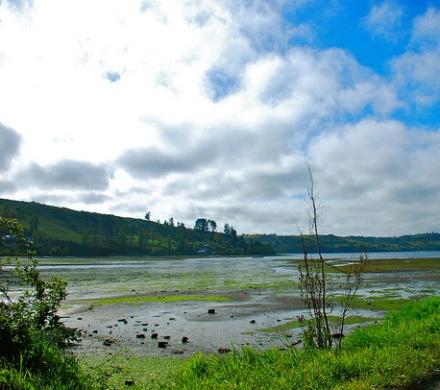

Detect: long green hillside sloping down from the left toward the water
[0, 199, 274, 256]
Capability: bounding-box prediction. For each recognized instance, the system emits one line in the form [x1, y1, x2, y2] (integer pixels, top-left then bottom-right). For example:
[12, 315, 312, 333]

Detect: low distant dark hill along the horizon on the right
[246, 233, 440, 253]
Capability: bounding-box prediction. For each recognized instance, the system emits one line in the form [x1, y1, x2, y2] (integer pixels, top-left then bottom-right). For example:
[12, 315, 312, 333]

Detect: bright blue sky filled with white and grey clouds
[0, 0, 440, 236]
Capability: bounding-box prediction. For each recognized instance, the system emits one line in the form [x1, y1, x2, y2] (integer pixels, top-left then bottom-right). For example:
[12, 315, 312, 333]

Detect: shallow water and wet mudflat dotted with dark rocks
[32, 252, 440, 355]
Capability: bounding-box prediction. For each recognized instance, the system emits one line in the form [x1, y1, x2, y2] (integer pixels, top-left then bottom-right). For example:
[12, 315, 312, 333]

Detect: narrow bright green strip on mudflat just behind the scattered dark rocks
[82, 295, 231, 306]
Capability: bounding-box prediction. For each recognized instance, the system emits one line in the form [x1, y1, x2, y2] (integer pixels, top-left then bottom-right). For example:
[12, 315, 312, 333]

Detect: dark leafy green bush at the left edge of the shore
[0, 217, 88, 389]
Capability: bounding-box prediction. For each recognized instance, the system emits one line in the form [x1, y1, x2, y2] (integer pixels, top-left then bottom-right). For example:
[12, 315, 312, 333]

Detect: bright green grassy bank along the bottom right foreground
[78, 297, 440, 390]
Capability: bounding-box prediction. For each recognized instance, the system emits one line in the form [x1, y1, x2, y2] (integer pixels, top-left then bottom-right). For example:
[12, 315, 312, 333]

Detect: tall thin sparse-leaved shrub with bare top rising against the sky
[298, 164, 367, 348]
